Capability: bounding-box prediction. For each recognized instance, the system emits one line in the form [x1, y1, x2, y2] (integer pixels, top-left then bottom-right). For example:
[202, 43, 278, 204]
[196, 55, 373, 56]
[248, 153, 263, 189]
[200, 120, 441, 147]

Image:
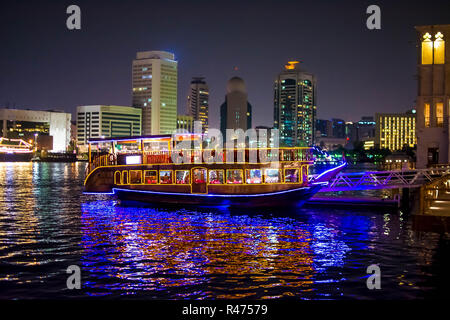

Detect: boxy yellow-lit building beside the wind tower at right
[375, 110, 417, 151]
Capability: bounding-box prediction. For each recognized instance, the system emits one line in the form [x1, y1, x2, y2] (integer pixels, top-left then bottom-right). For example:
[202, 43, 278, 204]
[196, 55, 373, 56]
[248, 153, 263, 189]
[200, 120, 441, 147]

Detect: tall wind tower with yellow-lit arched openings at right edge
[416, 24, 450, 168]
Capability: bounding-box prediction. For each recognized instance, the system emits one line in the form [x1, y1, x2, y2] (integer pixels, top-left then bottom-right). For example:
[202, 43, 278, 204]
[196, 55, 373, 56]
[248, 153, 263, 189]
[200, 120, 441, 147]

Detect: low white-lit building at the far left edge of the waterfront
[0, 108, 72, 152]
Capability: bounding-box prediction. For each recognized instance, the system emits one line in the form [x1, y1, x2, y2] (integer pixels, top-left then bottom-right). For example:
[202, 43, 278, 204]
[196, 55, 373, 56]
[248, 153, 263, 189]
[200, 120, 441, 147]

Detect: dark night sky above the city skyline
[0, 0, 450, 127]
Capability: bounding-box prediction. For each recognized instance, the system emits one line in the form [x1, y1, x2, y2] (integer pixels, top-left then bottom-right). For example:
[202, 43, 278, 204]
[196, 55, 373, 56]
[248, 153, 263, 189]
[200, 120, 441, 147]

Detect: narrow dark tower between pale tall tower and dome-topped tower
[187, 77, 209, 133]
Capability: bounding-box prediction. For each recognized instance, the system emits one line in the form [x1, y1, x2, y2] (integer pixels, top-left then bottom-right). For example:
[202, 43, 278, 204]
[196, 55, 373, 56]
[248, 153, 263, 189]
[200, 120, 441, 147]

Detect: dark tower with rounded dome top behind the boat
[220, 77, 252, 139]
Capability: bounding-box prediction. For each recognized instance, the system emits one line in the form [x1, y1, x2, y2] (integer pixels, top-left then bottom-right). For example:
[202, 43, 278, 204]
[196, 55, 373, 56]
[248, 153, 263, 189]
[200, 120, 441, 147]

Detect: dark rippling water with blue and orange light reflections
[0, 163, 450, 299]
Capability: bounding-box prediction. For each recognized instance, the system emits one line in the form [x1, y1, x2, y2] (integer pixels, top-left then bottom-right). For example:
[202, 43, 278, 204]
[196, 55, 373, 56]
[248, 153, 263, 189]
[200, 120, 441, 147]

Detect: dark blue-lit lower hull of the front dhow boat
[113, 185, 321, 208]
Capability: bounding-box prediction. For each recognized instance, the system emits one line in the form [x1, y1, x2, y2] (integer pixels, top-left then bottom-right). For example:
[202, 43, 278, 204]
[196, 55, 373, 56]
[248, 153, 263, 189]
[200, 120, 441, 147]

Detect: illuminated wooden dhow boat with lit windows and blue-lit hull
[84, 134, 340, 207]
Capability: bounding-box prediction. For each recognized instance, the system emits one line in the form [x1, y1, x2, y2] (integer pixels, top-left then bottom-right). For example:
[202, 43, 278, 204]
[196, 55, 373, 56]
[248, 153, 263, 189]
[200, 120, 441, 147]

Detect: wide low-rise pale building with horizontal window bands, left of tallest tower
[77, 105, 142, 151]
